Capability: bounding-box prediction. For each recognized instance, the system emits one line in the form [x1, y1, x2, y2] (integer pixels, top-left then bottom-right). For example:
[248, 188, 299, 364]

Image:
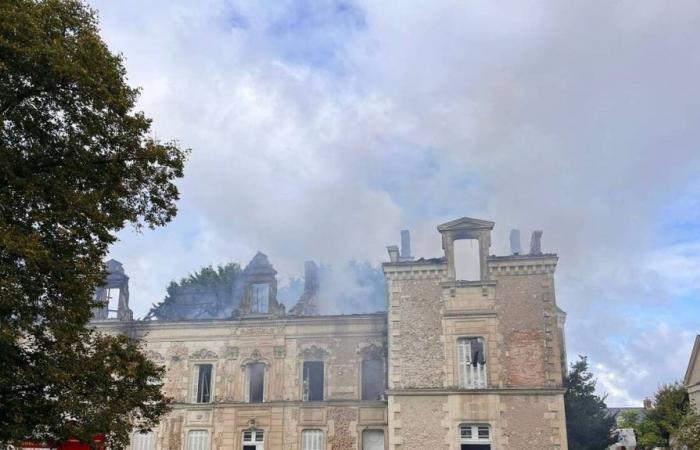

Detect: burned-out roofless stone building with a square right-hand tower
[94, 218, 567, 450]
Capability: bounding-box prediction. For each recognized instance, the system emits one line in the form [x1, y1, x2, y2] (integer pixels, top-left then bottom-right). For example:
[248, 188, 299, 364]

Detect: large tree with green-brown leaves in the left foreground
[0, 0, 186, 447]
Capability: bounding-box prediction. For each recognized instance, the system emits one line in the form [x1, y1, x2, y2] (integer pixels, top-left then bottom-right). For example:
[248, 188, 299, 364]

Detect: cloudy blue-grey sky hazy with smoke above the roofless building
[91, 0, 700, 406]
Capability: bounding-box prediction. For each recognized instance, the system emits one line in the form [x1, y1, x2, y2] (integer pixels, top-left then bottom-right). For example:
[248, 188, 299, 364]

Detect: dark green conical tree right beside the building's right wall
[564, 356, 615, 450]
